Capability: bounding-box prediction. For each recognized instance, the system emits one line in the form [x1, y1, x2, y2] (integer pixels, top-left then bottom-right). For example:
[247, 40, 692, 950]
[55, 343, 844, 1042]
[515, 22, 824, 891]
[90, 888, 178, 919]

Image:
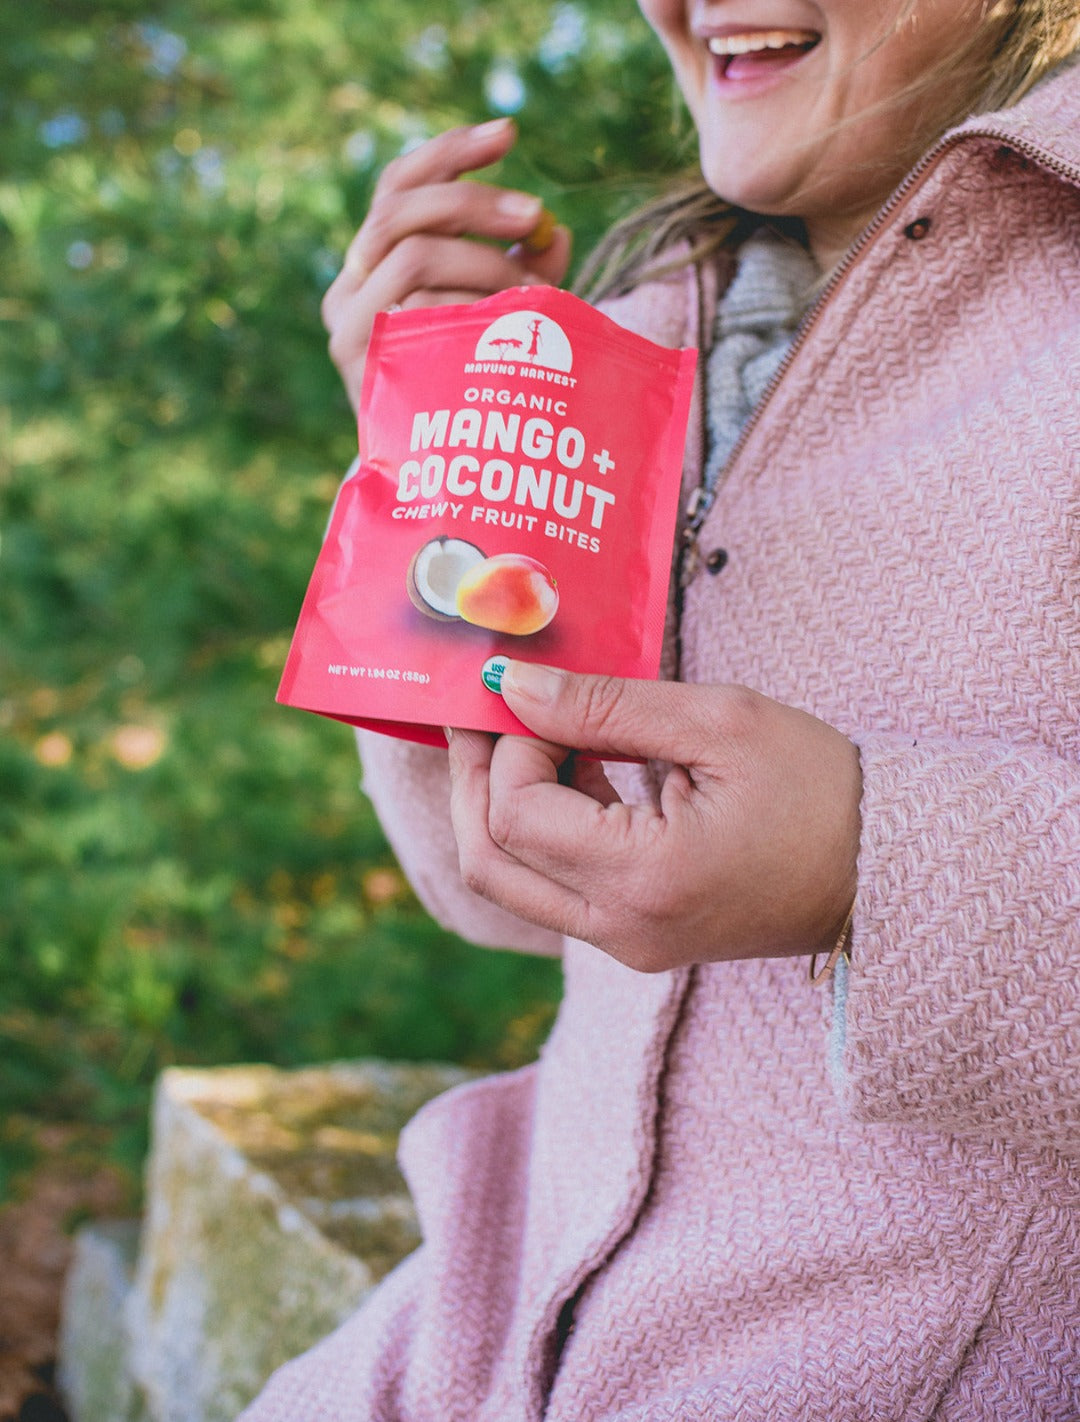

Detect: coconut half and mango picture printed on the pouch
[406, 535, 559, 637]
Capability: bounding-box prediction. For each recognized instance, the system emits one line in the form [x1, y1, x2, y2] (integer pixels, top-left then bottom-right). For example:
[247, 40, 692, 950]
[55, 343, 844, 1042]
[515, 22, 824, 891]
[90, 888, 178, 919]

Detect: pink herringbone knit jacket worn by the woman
[245, 70, 1080, 1422]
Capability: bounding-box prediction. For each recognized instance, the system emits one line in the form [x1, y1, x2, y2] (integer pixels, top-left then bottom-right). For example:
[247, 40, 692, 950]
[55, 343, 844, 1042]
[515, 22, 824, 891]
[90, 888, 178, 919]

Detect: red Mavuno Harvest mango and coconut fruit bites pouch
[277, 287, 696, 745]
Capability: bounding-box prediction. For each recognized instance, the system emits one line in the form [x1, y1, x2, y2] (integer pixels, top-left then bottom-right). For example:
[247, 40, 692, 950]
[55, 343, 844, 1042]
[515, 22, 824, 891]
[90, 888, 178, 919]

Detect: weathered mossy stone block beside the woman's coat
[61, 1061, 470, 1422]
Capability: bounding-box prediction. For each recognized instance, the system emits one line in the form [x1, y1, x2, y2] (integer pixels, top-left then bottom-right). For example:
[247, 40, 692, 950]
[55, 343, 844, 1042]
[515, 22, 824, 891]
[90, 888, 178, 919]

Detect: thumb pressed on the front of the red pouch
[501, 661, 703, 765]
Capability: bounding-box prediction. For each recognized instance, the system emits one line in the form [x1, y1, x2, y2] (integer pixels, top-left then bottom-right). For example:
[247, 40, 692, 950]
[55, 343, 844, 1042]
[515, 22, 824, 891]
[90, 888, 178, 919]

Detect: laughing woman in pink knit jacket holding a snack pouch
[245, 0, 1080, 1422]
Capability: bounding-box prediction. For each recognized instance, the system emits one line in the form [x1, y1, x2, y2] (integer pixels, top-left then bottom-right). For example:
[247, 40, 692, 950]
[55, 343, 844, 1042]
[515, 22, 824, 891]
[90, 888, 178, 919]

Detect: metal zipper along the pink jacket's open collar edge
[677, 120, 1080, 588]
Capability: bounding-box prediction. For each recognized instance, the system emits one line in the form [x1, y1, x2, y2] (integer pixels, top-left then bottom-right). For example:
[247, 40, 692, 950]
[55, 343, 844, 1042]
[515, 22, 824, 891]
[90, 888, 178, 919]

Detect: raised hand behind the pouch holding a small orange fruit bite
[323, 118, 571, 408]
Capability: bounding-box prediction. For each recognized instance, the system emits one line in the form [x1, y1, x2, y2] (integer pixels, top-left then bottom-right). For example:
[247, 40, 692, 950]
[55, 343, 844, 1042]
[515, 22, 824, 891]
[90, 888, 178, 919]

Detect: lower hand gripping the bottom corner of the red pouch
[450, 661, 861, 971]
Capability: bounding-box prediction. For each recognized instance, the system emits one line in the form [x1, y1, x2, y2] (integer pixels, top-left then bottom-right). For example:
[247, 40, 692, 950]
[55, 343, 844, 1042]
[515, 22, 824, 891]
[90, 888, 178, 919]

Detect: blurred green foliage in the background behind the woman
[0, 0, 686, 1189]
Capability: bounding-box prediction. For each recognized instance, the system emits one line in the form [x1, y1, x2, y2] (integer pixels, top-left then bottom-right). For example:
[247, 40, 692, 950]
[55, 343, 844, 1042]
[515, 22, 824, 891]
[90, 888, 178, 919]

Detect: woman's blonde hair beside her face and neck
[575, 0, 1080, 301]
